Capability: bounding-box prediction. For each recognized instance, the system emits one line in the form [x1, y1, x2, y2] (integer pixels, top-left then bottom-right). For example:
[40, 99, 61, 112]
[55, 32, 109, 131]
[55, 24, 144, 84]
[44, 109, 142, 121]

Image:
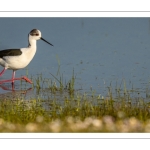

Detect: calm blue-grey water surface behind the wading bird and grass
[0, 18, 150, 97]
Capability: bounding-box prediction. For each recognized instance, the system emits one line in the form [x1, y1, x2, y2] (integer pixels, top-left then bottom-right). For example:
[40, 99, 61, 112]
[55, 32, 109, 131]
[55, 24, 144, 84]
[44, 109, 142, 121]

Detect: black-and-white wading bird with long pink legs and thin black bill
[0, 29, 53, 84]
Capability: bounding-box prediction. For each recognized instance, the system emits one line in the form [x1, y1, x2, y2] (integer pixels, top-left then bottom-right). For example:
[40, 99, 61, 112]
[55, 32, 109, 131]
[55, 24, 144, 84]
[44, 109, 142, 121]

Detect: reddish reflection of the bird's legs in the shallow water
[0, 83, 33, 99]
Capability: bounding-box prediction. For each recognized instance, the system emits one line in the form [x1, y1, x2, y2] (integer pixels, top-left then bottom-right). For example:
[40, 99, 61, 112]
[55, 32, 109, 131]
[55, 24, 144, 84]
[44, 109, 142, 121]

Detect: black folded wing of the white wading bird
[0, 49, 22, 58]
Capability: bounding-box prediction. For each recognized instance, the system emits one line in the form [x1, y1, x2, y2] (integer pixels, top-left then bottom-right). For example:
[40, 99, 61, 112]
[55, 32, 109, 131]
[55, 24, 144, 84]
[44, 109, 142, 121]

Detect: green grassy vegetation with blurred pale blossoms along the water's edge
[0, 66, 150, 132]
